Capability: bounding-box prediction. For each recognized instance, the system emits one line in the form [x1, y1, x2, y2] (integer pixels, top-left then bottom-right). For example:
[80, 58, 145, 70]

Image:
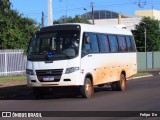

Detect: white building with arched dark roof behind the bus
[82, 10, 142, 30]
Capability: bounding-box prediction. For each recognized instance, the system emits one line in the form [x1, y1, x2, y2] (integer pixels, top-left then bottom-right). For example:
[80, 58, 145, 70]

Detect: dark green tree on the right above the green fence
[133, 17, 160, 52]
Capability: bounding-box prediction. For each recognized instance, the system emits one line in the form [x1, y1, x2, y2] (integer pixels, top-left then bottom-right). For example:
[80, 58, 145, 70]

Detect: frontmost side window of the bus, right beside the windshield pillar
[82, 33, 91, 55]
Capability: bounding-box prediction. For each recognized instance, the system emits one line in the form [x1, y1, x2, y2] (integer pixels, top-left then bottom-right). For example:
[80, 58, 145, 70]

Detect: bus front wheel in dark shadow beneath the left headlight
[33, 87, 44, 99]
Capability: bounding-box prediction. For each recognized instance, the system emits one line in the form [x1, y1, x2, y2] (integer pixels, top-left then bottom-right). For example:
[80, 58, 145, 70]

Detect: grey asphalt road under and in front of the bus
[0, 75, 160, 119]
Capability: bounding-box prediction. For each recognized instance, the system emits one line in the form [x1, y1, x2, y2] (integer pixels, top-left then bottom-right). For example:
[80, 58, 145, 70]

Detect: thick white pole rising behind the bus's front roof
[48, 0, 53, 26]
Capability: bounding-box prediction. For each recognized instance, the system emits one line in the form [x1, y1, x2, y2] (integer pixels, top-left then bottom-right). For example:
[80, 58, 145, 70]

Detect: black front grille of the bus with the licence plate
[36, 69, 63, 82]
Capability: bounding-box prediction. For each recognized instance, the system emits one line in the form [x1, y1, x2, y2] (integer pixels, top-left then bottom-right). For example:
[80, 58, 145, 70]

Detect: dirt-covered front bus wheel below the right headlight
[80, 78, 94, 98]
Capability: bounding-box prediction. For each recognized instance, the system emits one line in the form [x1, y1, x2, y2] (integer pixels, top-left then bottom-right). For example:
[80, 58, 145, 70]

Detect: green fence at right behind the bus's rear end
[137, 52, 160, 71]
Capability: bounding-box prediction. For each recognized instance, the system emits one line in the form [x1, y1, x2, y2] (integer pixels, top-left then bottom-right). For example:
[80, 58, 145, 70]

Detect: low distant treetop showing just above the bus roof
[53, 15, 90, 24]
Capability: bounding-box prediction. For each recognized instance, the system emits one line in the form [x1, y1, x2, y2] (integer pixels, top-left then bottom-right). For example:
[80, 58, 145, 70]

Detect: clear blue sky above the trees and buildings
[10, 0, 160, 24]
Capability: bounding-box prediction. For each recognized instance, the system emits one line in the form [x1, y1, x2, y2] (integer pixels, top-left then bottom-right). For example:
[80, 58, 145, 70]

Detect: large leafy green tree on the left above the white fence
[0, 0, 39, 51]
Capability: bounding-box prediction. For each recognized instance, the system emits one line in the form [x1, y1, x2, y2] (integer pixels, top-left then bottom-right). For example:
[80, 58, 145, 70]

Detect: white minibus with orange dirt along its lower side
[26, 23, 137, 98]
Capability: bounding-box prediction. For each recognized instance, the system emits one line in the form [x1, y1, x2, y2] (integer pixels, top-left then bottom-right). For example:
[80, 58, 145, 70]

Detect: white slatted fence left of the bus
[0, 50, 26, 76]
